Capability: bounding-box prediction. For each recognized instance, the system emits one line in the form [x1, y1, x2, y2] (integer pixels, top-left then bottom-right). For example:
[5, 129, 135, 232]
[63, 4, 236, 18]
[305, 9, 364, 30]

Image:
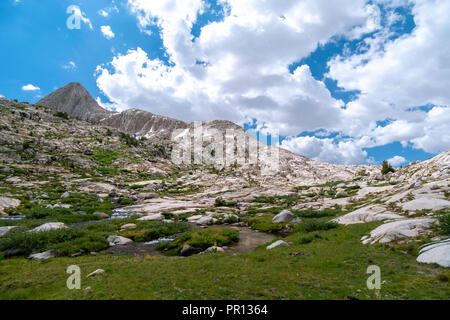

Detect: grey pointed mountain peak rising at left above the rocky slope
[37, 82, 111, 120]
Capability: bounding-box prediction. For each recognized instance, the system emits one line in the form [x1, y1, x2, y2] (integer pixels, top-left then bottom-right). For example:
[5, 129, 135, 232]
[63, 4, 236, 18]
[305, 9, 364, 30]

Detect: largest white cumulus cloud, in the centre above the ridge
[97, 0, 371, 135]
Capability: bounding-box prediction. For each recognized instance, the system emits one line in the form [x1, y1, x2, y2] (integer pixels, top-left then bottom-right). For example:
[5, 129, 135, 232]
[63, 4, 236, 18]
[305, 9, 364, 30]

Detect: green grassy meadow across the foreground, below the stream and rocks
[0, 223, 450, 300]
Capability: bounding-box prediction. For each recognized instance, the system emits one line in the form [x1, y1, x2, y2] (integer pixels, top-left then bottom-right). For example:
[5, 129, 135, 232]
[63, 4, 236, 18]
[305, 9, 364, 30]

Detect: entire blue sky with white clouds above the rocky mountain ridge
[0, 0, 450, 165]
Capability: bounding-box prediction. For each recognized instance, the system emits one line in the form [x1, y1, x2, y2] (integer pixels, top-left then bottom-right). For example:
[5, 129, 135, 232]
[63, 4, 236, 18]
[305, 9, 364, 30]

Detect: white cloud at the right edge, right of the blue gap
[329, 0, 450, 153]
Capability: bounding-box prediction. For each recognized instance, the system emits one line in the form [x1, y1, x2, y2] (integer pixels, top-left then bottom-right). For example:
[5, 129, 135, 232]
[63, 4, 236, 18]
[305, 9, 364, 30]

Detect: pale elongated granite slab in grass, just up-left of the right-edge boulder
[362, 218, 436, 244]
